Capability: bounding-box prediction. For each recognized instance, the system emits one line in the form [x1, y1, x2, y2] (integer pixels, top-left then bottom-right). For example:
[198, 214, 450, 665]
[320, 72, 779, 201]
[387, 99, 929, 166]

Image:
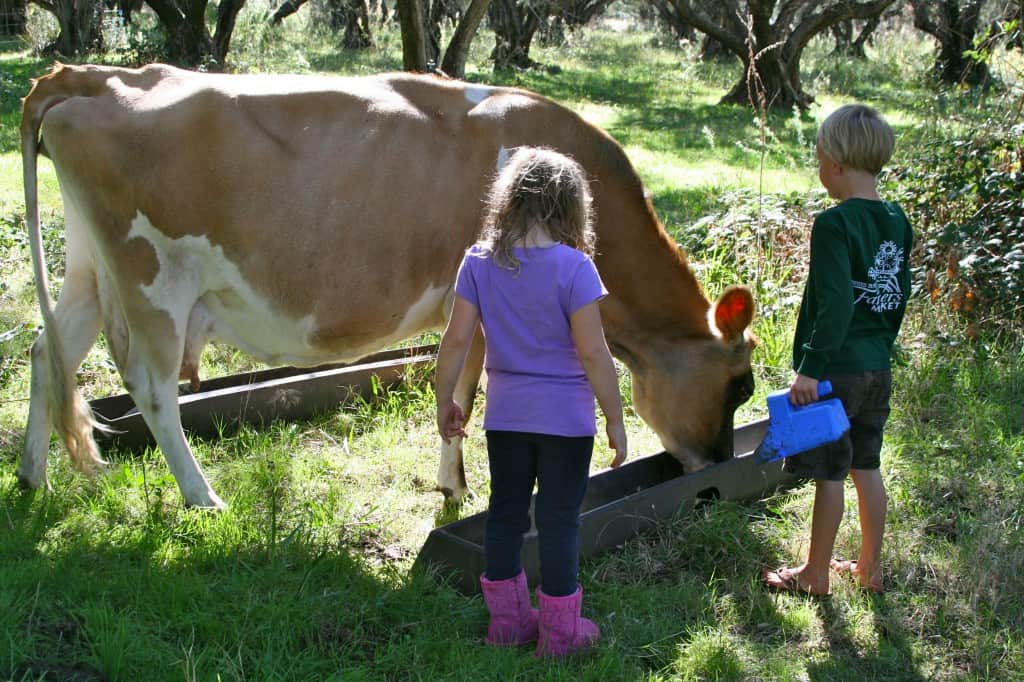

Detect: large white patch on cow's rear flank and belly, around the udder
[127, 213, 321, 364]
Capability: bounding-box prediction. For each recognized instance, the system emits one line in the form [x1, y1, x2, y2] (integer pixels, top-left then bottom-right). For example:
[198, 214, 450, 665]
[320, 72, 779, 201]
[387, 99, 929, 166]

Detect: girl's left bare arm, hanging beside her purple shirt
[434, 295, 480, 442]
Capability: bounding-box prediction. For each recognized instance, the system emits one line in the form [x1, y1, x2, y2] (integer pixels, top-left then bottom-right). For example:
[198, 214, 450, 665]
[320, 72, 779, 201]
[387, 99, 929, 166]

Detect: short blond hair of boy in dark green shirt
[817, 104, 896, 175]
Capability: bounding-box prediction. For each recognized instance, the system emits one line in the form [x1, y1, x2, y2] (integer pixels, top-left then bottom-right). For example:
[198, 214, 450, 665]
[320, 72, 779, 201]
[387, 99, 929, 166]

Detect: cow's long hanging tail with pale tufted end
[22, 70, 105, 473]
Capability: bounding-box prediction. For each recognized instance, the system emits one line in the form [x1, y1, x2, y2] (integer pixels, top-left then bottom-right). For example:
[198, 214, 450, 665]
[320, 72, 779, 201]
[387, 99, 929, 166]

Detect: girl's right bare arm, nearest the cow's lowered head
[569, 301, 629, 468]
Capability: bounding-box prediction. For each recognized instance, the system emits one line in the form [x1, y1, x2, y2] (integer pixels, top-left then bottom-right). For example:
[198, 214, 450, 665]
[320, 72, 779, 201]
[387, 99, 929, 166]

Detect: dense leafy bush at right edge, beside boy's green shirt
[889, 119, 1024, 331]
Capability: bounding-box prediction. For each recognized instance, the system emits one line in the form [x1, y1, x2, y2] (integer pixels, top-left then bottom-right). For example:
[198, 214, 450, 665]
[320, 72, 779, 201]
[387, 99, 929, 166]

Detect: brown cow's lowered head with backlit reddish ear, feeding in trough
[629, 287, 756, 473]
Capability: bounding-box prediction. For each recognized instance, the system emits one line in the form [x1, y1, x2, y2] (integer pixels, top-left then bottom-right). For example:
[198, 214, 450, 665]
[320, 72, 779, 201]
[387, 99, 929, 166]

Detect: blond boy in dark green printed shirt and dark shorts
[763, 104, 913, 595]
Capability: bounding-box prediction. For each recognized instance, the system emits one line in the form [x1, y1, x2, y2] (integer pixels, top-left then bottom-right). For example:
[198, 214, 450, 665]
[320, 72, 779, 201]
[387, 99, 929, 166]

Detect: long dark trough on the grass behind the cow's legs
[89, 345, 437, 450]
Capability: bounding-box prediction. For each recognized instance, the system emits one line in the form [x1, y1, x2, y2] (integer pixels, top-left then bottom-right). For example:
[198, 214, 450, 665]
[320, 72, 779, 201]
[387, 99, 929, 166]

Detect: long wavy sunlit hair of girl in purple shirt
[479, 146, 595, 271]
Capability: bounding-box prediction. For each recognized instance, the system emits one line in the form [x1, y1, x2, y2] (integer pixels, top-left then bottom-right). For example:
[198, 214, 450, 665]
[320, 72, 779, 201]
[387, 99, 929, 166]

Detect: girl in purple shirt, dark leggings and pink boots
[436, 147, 627, 656]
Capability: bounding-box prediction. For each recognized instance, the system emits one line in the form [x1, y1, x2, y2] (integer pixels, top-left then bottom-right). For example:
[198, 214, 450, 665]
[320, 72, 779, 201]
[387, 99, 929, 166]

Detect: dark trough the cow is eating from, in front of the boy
[416, 420, 797, 594]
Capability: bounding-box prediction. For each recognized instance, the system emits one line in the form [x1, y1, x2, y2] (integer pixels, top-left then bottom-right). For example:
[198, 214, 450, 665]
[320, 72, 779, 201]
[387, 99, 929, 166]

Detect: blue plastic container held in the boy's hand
[756, 381, 850, 462]
